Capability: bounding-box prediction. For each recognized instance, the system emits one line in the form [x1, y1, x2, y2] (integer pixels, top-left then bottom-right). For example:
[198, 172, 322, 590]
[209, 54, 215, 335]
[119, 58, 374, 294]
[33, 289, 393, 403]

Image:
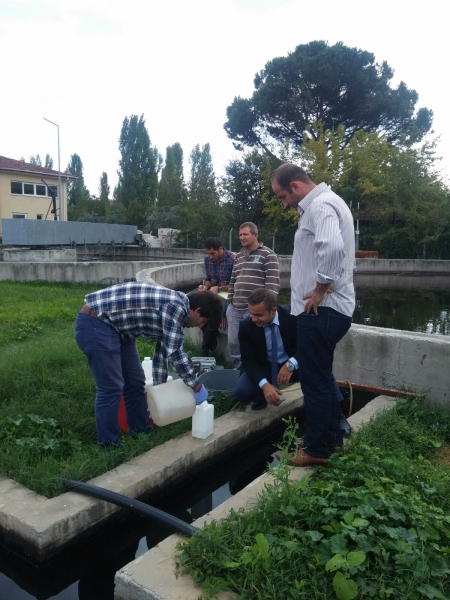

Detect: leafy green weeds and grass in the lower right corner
[179, 401, 450, 600]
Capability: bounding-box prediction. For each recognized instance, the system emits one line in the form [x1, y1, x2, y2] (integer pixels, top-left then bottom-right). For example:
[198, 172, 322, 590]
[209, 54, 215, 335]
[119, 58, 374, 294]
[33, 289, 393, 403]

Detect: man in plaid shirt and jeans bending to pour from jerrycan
[75, 283, 222, 447]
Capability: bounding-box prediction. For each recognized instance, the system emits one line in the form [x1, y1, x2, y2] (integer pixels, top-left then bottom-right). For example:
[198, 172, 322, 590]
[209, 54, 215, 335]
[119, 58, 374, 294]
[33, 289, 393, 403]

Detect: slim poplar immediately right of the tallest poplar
[158, 142, 187, 209]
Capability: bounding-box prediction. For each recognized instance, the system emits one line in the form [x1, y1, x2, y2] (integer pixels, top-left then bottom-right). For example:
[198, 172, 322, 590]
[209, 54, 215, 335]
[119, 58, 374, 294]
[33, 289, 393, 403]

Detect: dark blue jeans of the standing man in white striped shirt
[297, 307, 352, 458]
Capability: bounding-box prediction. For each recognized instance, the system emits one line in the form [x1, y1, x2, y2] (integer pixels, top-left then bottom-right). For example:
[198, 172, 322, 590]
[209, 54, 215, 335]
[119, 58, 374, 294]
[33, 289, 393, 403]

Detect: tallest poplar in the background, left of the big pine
[115, 115, 162, 216]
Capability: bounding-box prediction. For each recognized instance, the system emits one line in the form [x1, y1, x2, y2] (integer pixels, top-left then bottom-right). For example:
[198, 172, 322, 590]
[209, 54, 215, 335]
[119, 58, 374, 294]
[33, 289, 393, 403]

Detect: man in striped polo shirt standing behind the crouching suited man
[227, 222, 280, 369]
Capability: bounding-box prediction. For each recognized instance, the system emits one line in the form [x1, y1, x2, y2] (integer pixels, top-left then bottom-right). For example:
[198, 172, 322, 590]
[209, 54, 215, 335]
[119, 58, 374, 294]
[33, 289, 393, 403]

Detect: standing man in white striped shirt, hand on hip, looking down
[272, 164, 355, 467]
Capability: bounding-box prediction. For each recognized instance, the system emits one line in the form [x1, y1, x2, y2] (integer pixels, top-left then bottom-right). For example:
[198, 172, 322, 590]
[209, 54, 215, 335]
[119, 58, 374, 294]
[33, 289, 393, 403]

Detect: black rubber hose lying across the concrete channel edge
[62, 479, 199, 537]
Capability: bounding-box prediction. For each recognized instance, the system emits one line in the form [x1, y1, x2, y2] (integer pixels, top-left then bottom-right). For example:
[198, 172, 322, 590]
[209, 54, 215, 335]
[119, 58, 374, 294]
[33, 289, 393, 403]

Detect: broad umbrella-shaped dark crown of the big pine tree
[224, 41, 433, 154]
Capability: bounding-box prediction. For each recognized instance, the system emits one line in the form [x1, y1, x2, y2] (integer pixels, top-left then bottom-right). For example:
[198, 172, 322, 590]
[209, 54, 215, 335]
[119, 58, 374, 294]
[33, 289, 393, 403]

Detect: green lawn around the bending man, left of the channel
[0, 281, 234, 497]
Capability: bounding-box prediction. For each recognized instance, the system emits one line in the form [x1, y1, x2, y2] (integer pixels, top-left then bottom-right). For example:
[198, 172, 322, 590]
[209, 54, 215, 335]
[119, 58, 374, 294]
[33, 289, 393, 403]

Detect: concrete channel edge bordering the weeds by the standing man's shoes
[114, 396, 395, 600]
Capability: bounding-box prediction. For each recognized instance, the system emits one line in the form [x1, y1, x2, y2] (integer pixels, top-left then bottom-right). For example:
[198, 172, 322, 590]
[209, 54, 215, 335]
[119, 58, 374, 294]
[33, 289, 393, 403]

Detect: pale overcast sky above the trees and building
[0, 0, 450, 194]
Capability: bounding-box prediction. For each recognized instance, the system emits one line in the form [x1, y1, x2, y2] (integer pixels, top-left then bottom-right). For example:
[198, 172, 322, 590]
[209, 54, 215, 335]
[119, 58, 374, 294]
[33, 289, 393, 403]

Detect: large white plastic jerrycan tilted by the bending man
[147, 379, 196, 427]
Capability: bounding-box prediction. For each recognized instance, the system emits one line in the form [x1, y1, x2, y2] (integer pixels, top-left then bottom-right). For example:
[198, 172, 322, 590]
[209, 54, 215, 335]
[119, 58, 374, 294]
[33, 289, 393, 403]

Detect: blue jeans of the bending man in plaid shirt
[75, 312, 148, 446]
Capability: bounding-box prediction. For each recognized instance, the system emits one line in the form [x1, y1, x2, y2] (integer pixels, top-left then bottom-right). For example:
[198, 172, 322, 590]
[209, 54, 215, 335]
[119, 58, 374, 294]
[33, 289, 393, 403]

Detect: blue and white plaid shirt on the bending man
[85, 283, 199, 387]
